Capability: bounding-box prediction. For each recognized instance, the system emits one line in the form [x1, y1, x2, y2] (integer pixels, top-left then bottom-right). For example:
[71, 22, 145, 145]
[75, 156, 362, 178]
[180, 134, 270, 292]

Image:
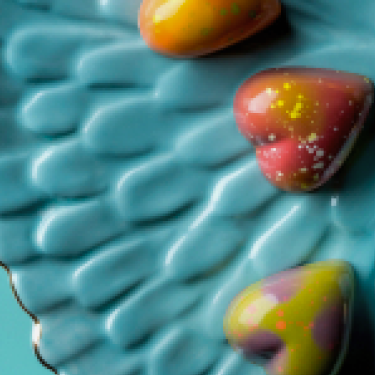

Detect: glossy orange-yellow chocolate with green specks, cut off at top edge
[139, 0, 281, 57]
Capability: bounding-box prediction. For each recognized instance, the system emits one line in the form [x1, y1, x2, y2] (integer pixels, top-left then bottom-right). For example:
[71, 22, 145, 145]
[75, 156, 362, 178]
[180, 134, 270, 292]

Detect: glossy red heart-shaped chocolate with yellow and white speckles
[234, 67, 374, 191]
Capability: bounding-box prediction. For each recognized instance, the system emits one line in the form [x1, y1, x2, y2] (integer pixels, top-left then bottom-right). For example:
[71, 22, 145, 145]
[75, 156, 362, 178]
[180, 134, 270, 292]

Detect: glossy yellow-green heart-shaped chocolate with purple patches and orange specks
[224, 261, 354, 375]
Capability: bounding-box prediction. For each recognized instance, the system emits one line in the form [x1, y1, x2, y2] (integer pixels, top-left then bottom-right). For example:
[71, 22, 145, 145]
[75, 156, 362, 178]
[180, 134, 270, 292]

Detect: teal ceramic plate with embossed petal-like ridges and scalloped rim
[0, 0, 375, 375]
